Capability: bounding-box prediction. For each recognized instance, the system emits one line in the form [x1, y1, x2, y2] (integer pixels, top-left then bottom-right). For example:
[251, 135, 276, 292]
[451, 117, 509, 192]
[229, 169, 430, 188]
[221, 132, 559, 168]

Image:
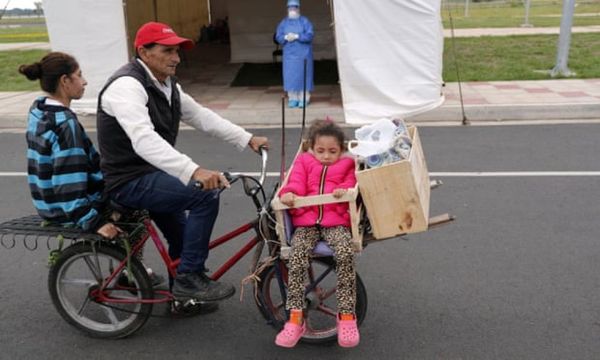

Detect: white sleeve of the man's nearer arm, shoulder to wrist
[101, 76, 199, 185]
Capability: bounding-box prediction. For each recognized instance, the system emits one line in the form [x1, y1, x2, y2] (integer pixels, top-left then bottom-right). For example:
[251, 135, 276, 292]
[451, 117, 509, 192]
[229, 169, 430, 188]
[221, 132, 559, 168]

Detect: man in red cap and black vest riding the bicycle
[97, 22, 268, 301]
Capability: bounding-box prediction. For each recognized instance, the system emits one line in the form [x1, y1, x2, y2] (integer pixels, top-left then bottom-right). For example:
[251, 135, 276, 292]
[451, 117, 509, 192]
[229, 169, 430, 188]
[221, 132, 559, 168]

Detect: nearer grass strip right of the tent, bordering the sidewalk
[443, 33, 600, 82]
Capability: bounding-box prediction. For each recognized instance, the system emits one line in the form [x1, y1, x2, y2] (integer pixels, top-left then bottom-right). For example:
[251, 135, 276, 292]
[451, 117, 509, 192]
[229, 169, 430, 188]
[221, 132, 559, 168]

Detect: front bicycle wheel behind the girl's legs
[258, 257, 367, 343]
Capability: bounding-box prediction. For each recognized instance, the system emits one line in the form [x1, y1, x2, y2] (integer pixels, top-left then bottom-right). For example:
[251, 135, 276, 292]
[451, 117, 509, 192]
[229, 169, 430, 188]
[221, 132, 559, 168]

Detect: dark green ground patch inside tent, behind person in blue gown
[231, 60, 338, 86]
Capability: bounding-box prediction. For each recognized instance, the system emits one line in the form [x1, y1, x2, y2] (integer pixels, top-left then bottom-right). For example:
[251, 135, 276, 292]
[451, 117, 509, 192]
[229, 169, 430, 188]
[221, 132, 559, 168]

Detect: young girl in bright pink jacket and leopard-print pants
[275, 120, 360, 347]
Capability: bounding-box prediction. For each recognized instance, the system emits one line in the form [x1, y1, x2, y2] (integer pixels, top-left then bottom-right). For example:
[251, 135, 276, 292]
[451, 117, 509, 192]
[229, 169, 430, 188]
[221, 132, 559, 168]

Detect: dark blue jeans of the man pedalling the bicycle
[110, 171, 219, 273]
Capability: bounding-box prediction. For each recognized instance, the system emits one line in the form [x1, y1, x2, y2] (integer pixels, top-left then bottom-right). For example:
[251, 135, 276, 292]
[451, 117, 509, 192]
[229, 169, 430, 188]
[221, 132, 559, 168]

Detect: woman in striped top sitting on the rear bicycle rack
[19, 52, 121, 239]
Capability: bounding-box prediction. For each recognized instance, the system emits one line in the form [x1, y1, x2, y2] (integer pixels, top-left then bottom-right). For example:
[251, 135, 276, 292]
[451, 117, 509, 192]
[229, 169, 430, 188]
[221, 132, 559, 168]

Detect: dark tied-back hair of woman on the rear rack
[19, 51, 79, 94]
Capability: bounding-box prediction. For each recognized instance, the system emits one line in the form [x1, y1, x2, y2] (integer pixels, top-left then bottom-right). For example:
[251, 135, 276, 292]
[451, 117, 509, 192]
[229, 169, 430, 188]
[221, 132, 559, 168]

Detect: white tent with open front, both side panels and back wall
[44, 0, 443, 123]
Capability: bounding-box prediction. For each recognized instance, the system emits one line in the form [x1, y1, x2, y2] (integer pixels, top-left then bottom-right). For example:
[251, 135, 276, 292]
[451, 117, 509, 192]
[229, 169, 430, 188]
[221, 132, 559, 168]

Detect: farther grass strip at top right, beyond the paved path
[442, 0, 600, 29]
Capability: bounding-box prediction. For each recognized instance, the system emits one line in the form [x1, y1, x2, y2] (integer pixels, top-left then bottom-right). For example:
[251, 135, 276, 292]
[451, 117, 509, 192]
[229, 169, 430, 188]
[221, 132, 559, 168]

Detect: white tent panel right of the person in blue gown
[334, 0, 444, 124]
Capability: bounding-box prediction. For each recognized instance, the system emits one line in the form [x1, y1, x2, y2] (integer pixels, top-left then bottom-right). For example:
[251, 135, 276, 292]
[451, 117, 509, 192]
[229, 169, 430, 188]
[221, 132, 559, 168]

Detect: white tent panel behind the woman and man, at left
[43, 0, 129, 113]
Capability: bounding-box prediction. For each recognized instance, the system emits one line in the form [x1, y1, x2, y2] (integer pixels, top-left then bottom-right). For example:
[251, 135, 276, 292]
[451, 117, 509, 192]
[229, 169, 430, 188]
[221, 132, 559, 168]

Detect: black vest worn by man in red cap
[96, 59, 181, 191]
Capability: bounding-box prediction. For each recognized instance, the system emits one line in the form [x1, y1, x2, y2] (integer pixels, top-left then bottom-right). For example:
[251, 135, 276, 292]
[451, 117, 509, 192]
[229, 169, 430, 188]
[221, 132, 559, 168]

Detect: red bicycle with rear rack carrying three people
[0, 150, 367, 343]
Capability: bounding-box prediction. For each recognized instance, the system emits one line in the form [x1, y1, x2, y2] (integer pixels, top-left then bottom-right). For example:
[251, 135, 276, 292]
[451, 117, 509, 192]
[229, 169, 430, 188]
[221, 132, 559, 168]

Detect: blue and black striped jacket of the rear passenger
[26, 97, 104, 231]
